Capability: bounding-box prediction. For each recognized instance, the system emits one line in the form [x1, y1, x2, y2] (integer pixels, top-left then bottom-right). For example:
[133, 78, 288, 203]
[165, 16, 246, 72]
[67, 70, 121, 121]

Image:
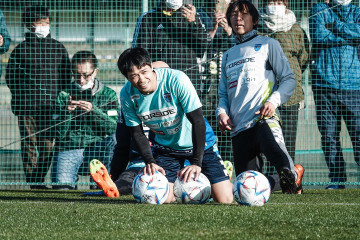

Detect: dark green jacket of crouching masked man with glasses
[53, 80, 119, 151]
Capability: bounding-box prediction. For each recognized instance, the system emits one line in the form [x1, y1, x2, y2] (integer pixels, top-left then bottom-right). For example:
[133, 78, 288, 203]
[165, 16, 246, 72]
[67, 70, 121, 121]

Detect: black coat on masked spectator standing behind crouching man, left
[5, 32, 71, 116]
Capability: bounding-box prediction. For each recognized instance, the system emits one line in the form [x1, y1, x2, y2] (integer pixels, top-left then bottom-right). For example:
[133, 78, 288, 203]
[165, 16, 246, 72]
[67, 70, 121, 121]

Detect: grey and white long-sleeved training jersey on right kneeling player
[216, 30, 296, 137]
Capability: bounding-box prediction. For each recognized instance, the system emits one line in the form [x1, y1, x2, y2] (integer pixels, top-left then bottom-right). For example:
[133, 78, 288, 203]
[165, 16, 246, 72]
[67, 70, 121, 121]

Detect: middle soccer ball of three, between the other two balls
[174, 173, 211, 204]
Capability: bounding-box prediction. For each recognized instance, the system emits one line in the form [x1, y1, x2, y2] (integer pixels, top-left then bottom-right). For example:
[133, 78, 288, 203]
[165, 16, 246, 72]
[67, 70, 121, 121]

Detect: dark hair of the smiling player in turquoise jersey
[117, 47, 151, 77]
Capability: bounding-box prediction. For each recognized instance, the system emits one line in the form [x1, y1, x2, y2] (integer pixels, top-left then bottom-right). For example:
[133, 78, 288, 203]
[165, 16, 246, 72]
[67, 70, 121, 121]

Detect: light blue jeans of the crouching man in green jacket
[51, 134, 116, 188]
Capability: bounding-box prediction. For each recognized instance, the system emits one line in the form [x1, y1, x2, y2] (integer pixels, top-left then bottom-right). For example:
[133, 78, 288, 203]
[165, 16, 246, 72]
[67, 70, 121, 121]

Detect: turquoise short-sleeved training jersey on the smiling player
[120, 68, 202, 150]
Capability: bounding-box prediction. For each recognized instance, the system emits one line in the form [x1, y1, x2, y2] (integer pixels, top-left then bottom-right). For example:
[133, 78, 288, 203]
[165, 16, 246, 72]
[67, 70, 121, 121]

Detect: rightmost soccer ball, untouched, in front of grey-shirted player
[233, 171, 271, 206]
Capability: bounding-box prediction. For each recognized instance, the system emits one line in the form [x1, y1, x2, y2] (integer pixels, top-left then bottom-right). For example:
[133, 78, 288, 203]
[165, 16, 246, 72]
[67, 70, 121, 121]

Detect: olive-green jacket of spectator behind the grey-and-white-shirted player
[259, 24, 309, 106]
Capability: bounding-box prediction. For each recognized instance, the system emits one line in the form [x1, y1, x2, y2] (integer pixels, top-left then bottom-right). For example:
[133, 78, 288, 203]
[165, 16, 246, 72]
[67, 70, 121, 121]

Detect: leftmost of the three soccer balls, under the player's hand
[132, 171, 170, 204]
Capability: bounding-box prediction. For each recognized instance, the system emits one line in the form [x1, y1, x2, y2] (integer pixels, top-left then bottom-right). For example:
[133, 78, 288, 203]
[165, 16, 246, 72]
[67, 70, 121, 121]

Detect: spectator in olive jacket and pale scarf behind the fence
[258, 0, 309, 160]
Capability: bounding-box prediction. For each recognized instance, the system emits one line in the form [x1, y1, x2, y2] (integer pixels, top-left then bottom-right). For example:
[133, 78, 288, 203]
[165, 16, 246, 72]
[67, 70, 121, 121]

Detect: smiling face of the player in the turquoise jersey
[127, 65, 157, 95]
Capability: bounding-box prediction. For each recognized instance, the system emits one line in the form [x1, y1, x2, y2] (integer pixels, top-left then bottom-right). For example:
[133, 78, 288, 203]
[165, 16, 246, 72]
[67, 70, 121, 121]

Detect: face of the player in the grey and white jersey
[230, 5, 255, 36]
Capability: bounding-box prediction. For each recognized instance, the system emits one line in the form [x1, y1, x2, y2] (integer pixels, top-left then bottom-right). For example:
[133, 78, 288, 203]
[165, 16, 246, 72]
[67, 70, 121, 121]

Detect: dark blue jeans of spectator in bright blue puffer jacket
[313, 87, 360, 181]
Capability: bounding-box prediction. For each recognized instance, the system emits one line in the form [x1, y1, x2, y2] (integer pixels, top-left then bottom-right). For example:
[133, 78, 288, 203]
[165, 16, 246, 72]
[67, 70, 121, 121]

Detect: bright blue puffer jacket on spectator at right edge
[309, 3, 360, 90]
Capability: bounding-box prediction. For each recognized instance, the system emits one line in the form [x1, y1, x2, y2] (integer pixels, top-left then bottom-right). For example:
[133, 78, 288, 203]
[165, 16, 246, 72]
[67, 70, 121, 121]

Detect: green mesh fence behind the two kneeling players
[0, 0, 360, 188]
